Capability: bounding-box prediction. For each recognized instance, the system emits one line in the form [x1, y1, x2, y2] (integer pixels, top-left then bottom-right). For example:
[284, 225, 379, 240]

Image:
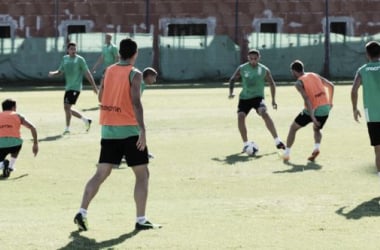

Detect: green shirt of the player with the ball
[240, 62, 269, 100]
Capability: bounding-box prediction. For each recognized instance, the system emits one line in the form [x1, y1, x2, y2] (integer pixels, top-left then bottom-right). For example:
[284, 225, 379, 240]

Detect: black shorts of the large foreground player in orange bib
[99, 136, 149, 167]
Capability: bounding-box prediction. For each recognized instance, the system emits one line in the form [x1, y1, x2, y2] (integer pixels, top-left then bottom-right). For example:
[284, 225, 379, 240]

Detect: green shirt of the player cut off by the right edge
[358, 61, 380, 122]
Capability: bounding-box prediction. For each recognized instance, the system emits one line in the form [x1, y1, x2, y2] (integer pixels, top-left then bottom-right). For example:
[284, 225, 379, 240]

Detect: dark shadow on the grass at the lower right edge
[335, 197, 380, 220]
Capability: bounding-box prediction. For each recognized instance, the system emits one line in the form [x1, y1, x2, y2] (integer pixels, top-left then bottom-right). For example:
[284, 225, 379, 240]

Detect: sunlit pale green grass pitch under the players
[0, 86, 380, 250]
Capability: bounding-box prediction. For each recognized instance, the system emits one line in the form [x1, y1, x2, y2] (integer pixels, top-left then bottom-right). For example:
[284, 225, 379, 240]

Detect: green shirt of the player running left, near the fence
[58, 55, 88, 91]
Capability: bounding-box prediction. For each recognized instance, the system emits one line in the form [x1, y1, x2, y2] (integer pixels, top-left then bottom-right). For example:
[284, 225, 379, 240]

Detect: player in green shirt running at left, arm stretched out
[49, 42, 98, 134]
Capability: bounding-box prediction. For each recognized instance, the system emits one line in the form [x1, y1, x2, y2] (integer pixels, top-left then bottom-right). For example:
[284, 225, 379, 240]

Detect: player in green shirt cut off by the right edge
[351, 41, 380, 176]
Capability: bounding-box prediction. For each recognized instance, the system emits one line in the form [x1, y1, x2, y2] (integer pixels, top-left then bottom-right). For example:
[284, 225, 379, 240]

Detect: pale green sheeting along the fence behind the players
[0, 33, 380, 82]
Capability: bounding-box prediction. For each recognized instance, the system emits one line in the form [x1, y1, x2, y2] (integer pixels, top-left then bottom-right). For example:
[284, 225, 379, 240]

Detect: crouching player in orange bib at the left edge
[0, 99, 38, 178]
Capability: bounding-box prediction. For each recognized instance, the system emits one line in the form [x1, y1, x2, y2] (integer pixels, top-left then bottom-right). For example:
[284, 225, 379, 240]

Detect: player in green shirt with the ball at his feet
[229, 49, 285, 152]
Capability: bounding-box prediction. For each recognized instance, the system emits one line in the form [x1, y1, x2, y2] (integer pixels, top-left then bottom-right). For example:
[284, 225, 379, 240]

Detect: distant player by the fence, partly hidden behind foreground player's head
[92, 34, 119, 73]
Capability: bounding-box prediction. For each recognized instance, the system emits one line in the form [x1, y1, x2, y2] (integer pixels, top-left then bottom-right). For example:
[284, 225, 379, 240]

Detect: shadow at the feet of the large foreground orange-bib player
[58, 230, 140, 250]
